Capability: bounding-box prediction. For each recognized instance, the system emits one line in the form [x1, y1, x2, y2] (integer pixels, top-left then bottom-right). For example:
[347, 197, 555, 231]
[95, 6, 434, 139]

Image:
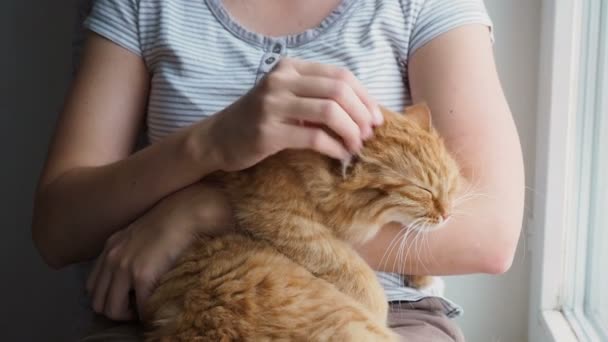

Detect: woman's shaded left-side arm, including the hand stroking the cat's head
[32, 34, 382, 267]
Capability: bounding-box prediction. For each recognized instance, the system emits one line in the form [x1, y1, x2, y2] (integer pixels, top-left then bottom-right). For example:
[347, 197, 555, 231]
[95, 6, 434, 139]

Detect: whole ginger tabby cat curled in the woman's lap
[147, 105, 460, 341]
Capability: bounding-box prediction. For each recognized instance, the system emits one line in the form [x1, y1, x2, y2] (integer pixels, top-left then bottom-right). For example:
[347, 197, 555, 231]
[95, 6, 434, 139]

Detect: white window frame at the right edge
[528, 0, 608, 342]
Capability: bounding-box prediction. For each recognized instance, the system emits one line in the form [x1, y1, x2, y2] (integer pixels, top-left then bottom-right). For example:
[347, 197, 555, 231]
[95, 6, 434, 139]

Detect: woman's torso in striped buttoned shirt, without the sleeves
[89, 0, 416, 142]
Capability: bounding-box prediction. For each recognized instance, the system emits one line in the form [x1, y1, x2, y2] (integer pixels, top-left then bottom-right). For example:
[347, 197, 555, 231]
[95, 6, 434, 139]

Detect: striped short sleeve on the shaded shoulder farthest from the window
[84, 0, 142, 56]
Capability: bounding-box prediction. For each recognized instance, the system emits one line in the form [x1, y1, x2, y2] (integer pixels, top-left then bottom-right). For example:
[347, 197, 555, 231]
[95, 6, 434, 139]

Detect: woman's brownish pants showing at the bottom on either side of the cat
[80, 299, 464, 342]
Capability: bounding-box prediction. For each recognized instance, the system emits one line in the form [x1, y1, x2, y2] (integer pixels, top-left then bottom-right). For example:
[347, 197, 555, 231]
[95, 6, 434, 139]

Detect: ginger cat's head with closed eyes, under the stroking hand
[312, 104, 460, 240]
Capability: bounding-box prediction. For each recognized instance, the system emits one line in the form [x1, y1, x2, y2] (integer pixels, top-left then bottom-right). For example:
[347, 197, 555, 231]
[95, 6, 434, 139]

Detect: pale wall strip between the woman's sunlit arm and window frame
[447, 0, 541, 342]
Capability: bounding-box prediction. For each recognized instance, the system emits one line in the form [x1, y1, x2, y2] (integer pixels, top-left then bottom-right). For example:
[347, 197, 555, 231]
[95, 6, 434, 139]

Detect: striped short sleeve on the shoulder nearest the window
[408, 0, 494, 56]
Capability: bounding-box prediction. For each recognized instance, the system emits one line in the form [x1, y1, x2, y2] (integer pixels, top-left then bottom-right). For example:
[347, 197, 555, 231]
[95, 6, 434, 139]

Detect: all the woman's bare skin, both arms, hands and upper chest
[32, 0, 524, 320]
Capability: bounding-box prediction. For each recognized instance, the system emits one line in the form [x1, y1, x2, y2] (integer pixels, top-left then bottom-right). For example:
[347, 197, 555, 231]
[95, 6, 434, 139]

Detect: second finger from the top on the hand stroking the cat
[290, 76, 374, 139]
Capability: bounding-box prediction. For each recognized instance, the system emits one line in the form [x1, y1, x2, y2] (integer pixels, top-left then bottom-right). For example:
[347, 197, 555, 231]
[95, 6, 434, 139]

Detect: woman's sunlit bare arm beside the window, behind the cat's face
[361, 25, 524, 275]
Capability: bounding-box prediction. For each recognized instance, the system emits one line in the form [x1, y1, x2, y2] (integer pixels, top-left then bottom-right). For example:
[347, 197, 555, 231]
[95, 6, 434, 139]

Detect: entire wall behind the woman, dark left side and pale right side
[0, 0, 540, 342]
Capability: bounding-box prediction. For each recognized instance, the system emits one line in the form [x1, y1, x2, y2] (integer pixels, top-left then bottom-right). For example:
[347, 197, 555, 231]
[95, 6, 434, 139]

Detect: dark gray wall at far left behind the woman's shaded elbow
[0, 0, 84, 341]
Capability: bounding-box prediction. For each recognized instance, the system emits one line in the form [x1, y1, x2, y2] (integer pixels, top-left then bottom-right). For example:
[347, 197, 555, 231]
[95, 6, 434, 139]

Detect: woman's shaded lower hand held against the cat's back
[87, 183, 234, 321]
